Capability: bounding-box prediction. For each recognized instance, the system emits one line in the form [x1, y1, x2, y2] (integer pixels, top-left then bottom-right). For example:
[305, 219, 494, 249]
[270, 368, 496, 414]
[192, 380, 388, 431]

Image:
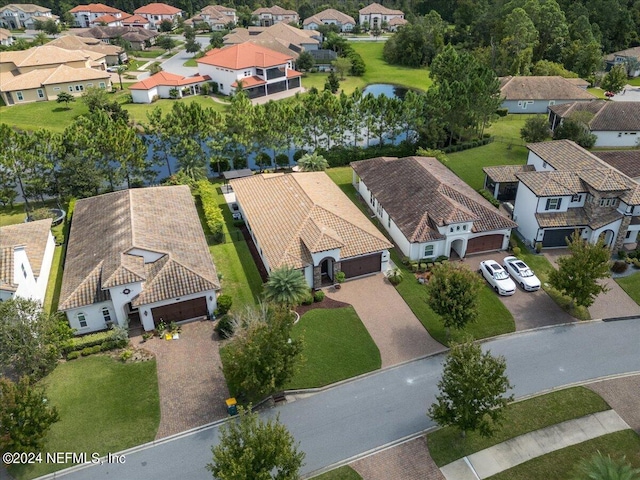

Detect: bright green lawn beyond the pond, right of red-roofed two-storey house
[302, 42, 432, 93]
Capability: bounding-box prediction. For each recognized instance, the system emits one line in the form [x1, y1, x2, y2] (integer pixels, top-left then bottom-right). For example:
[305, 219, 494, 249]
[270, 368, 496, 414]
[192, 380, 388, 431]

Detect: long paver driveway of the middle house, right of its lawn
[327, 273, 446, 368]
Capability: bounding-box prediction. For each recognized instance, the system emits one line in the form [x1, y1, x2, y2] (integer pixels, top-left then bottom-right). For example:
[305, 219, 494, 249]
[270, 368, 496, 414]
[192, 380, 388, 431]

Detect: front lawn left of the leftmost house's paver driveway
[10, 355, 160, 479]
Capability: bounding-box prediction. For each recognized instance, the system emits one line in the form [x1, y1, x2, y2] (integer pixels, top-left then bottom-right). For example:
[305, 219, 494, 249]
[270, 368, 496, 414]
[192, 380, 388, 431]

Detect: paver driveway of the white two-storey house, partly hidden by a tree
[544, 248, 640, 320]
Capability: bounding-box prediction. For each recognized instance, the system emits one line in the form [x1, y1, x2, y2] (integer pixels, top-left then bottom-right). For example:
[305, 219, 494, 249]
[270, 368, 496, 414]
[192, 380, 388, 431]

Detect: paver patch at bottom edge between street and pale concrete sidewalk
[350, 437, 444, 480]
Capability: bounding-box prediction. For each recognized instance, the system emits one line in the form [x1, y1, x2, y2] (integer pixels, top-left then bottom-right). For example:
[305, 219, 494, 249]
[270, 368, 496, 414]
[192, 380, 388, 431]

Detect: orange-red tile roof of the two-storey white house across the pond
[196, 42, 293, 70]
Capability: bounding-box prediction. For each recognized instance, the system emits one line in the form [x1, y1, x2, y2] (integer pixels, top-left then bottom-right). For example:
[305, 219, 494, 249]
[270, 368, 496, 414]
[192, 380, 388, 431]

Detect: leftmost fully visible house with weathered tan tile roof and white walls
[59, 186, 220, 334]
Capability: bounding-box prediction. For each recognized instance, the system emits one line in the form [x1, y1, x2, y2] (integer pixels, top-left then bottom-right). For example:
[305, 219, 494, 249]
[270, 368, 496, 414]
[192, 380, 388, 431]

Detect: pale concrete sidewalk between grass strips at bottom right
[440, 410, 629, 480]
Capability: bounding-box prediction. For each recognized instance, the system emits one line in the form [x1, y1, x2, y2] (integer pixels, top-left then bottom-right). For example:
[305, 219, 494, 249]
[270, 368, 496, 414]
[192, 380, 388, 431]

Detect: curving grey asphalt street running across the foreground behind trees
[48, 318, 640, 480]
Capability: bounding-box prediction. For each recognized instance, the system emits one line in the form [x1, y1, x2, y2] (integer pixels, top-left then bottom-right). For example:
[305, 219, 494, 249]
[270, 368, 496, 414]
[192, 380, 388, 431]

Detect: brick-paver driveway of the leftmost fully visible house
[132, 320, 229, 440]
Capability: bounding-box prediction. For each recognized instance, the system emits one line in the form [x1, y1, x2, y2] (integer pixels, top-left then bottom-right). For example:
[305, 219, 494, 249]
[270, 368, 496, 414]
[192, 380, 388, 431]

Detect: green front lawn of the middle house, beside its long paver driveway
[287, 307, 381, 389]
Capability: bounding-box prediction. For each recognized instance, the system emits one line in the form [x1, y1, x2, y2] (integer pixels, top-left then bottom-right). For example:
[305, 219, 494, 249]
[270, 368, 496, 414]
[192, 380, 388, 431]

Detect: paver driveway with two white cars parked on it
[463, 252, 576, 331]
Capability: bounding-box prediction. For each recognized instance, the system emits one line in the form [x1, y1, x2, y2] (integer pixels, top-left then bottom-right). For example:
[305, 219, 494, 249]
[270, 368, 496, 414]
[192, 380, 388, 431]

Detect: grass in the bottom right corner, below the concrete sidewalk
[489, 430, 640, 480]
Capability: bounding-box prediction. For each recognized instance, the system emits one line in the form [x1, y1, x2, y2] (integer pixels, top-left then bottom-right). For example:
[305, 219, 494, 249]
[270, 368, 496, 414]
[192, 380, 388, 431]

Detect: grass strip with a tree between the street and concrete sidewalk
[427, 387, 610, 468]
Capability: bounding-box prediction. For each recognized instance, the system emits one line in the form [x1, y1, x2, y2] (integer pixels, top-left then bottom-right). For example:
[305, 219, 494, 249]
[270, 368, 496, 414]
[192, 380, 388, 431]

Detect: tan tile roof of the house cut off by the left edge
[0, 218, 51, 284]
